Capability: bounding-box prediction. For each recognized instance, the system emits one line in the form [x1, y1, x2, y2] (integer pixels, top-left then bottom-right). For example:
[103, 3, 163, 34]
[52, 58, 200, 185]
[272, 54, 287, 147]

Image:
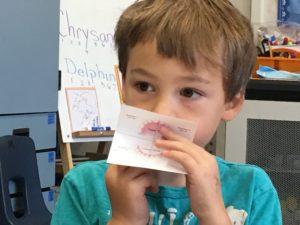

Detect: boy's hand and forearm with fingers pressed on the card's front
[155, 127, 231, 224]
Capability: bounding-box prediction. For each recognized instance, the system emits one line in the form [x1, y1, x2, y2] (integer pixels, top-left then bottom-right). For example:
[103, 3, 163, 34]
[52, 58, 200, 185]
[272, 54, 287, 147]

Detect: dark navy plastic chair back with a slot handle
[0, 135, 51, 225]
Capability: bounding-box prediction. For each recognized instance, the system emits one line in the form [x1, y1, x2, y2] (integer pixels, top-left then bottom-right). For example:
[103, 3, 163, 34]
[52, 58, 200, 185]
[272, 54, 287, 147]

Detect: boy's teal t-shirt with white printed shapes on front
[51, 157, 282, 225]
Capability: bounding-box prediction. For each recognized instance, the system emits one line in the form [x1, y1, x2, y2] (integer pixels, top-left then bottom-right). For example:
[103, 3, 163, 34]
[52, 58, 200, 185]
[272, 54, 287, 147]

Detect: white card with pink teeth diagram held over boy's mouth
[107, 105, 196, 174]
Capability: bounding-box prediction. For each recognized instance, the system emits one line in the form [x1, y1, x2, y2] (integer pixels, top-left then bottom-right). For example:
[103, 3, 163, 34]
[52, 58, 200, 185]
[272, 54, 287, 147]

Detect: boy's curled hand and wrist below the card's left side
[105, 165, 157, 225]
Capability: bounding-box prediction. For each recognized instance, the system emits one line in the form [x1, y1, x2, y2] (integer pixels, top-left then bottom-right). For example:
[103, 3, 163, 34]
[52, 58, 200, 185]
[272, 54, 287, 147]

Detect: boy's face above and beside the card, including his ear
[123, 42, 243, 147]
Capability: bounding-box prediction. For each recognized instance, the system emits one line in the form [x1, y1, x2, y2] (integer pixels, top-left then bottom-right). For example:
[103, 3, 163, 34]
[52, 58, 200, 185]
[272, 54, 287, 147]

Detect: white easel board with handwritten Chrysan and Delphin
[58, 0, 135, 142]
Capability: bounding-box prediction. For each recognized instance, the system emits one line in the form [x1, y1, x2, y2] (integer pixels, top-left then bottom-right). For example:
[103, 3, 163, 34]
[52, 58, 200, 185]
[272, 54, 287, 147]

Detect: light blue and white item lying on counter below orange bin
[256, 66, 300, 80]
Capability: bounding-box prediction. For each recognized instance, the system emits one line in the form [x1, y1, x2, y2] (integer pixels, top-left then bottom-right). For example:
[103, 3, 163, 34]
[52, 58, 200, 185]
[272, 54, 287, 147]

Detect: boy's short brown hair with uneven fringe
[115, 0, 256, 101]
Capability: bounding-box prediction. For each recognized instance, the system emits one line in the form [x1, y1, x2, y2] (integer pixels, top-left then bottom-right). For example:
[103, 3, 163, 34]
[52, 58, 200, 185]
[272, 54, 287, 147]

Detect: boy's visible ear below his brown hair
[222, 91, 245, 121]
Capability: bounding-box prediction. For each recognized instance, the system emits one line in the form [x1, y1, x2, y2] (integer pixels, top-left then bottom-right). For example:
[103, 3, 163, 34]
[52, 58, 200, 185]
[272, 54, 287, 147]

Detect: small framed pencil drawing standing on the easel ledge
[66, 87, 100, 132]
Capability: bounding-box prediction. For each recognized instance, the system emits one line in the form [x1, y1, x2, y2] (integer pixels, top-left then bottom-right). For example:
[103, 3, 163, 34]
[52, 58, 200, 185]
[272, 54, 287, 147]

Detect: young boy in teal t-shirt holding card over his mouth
[52, 0, 281, 225]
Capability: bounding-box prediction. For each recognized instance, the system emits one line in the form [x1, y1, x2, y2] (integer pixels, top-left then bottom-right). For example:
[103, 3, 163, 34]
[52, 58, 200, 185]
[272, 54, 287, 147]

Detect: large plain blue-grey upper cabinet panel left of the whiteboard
[0, 0, 59, 114]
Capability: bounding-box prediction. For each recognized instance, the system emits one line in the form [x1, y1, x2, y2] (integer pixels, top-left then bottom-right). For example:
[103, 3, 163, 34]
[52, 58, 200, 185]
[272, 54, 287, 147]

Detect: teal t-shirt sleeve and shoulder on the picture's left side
[51, 160, 111, 225]
